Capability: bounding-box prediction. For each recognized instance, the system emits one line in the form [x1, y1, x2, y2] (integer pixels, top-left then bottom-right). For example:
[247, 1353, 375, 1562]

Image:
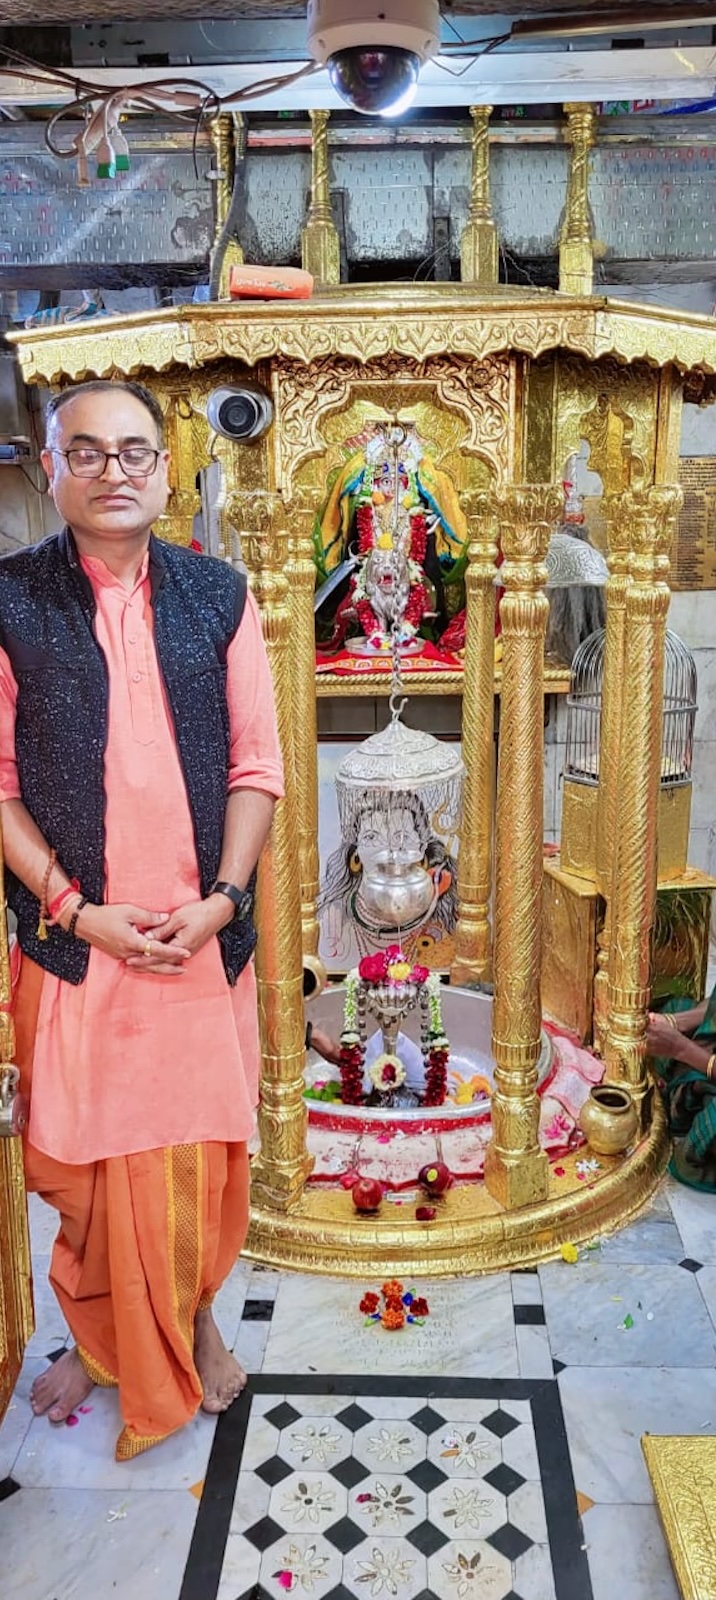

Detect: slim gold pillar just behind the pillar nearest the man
[288, 494, 320, 955]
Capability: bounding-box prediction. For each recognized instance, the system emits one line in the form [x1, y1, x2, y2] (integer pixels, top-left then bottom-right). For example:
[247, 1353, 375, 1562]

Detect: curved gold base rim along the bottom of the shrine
[245, 1098, 671, 1273]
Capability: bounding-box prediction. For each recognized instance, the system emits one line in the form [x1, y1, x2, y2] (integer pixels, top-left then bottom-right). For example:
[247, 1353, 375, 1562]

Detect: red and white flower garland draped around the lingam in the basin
[339, 944, 449, 1106]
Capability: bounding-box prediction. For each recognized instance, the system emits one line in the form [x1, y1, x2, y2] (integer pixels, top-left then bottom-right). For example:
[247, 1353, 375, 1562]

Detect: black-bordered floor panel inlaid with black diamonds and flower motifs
[182, 1378, 591, 1600]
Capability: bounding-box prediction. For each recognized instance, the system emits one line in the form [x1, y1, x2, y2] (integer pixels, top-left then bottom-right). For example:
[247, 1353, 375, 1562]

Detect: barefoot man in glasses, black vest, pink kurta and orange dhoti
[0, 381, 283, 1461]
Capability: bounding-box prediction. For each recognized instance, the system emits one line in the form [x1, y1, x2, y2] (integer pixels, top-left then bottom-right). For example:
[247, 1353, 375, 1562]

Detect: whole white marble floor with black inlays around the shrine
[0, 1182, 716, 1600]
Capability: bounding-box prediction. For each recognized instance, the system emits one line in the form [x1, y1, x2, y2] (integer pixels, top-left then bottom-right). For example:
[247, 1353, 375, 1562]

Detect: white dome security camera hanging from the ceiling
[308, 0, 440, 117]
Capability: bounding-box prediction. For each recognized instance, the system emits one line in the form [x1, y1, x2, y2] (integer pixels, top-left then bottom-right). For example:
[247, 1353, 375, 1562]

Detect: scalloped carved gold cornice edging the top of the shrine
[11, 283, 716, 398]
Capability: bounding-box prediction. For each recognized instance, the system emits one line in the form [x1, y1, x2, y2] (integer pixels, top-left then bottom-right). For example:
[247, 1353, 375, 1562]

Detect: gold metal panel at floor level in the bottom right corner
[641, 1434, 716, 1600]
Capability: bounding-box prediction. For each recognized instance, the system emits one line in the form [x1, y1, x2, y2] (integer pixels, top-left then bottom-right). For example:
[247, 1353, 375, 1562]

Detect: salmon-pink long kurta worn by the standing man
[0, 558, 283, 1163]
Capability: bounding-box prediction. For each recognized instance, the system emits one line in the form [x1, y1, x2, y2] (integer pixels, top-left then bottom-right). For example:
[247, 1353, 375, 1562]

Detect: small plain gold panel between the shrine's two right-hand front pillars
[542, 861, 603, 1043]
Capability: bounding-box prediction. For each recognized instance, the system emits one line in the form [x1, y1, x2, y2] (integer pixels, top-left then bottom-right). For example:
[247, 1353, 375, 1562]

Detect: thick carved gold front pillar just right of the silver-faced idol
[484, 485, 563, 1208]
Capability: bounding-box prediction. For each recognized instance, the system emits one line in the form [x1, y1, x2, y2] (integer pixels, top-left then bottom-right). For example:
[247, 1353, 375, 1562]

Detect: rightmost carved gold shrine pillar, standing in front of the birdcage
[604, 486, 682, 1123]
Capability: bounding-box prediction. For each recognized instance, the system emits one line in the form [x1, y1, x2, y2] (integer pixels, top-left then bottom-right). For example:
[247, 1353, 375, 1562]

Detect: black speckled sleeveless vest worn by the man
[0, 530, 256, 984]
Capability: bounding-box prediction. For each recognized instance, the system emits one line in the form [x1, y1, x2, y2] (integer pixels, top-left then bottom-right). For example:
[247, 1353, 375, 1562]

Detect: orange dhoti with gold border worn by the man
[13, 957, 249, 1461]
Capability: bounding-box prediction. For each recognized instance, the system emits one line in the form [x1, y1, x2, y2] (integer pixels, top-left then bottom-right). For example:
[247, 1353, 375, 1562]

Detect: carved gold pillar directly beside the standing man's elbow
[235, 493, 312, 1211]
